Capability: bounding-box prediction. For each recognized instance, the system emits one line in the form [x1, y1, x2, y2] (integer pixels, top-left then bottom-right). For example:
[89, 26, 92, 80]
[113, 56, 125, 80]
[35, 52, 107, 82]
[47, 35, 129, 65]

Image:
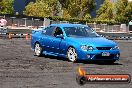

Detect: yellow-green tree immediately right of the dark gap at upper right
[97, 0, 114, 20]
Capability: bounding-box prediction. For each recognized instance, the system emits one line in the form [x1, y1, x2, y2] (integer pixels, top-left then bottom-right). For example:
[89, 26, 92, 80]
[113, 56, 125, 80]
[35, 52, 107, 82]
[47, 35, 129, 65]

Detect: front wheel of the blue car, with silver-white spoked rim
[67, 47, 77, 62]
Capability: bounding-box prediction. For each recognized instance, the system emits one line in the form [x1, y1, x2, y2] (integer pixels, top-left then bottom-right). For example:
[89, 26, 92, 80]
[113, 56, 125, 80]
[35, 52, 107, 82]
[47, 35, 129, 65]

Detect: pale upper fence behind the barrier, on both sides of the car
[0, 15, 129, 32]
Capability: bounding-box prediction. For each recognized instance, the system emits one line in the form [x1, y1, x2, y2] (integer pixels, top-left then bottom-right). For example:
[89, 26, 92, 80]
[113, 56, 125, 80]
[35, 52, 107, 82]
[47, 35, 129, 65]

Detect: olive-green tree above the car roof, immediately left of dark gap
[67, 0, 95, 18]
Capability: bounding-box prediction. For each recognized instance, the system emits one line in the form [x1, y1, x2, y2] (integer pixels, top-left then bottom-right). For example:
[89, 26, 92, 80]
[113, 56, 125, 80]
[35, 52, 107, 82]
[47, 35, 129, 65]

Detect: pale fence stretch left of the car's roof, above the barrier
[5, 17, 50, 28]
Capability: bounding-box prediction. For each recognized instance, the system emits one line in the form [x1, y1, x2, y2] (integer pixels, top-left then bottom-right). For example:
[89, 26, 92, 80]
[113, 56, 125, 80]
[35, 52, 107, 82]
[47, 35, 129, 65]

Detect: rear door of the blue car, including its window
[40, 26, 56, 52]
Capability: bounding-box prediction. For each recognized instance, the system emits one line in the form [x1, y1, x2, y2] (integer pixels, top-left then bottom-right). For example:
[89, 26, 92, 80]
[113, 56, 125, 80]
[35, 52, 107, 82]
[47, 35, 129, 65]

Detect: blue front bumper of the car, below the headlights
[77, 50, 120, 60]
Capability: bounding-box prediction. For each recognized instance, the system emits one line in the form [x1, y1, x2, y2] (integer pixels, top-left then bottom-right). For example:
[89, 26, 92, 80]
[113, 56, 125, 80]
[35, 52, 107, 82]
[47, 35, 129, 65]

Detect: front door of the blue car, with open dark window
[50, 27, 63, 54]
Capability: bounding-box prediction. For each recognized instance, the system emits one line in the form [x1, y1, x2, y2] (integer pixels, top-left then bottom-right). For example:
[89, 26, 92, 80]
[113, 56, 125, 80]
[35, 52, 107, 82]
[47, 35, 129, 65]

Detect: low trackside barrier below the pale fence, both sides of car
[0, 29, 132, 40]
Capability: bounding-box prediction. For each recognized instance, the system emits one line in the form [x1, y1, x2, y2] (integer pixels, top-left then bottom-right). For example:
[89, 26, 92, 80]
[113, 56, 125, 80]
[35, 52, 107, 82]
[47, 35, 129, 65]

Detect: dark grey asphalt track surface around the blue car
[0, 39, 132, 88]
